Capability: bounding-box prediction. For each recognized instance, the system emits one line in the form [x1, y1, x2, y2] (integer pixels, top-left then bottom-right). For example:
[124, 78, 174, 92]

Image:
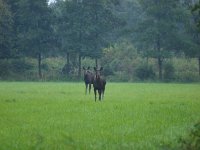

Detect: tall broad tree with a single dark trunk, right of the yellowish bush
[137, 0, 186, 80]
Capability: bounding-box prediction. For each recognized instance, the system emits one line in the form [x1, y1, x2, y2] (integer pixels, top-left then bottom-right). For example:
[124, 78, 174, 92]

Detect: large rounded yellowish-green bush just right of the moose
[101, 41, 141, 81]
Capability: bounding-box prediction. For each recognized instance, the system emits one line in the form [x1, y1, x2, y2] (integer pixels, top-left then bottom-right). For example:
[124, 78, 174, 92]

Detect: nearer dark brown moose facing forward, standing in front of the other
[93, 67, 106, 102]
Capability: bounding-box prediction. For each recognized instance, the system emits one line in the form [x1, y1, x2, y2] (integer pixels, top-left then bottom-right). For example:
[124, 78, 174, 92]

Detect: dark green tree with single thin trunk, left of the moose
[18, 0, 54, 78]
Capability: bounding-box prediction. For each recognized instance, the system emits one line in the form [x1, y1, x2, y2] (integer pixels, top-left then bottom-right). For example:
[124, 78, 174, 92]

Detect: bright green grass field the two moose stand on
[0, 82, 200, 150]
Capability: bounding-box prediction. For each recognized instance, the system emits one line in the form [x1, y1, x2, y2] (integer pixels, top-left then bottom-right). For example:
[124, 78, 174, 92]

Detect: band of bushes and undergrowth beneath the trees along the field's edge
[0, 54, 200, 82]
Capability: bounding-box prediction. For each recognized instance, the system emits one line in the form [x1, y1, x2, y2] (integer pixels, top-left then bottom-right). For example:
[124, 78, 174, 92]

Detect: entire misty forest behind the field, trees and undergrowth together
[0, 0, 200, 82]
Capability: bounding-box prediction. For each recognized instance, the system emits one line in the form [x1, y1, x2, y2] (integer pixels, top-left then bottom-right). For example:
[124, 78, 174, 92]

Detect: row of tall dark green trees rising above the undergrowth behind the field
[0, 0, 200, 80]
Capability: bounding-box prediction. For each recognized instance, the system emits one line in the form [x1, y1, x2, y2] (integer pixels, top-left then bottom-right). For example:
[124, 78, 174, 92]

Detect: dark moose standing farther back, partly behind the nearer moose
[83, 67, 94, 94]
